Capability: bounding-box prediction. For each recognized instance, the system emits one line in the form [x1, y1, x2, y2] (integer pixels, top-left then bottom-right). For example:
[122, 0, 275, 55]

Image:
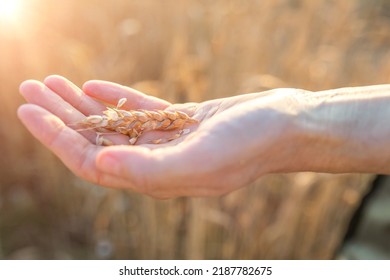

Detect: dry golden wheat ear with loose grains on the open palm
[77, 98, 198, 145]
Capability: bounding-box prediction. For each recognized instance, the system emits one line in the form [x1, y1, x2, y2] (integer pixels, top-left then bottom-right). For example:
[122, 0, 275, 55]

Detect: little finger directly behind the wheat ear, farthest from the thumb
[83, 80, 170, 110]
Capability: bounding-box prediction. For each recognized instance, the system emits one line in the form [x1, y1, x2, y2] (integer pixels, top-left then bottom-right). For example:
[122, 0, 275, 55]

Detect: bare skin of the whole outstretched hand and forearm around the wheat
[18, 76, 390, 199]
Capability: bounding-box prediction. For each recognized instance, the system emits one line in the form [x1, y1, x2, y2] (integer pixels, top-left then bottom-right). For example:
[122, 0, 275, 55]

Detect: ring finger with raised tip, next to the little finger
[44, 75, 106, 116]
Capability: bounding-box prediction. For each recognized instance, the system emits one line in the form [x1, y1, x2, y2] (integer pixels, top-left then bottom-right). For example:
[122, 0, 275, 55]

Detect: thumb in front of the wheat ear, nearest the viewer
[96, 139, 215, 198]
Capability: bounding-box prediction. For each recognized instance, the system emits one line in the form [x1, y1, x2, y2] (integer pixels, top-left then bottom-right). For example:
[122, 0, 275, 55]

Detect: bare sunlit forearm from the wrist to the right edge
[285, 85, 390, 174]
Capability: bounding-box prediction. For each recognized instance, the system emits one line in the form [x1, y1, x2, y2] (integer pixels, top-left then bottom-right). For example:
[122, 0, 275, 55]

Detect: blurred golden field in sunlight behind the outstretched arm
[0, 0, 390, 259]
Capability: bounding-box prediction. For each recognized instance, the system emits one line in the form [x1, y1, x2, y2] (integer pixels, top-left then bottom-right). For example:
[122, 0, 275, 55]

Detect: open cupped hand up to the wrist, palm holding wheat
[18, 76, 300, 199]
